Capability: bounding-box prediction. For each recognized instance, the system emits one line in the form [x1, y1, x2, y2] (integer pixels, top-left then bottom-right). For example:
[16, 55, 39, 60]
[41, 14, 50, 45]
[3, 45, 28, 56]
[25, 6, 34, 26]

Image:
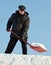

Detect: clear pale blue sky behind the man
[0, 0, 51, 56]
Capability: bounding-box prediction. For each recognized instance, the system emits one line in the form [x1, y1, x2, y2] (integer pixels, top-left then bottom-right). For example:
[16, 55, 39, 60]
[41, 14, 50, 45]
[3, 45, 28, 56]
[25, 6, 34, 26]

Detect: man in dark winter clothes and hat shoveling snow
[5, 5, 30, 54]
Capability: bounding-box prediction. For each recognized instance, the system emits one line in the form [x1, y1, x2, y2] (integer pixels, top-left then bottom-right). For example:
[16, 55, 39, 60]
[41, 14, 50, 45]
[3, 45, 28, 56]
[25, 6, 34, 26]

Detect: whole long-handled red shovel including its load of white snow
[9, 30, 47, 52]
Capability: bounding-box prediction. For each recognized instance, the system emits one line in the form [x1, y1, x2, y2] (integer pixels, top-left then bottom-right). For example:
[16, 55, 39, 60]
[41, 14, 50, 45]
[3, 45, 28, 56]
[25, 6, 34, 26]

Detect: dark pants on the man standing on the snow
[5, 38, 27, 54]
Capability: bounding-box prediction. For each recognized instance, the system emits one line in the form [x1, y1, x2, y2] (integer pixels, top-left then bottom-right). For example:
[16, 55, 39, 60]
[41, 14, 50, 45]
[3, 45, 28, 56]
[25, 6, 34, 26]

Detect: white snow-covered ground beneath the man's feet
[0, 54, 51, 65]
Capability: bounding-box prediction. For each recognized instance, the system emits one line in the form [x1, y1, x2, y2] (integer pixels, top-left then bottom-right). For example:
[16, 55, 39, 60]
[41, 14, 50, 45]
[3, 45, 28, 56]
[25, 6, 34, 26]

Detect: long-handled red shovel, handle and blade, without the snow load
[9, 30, 47, 52]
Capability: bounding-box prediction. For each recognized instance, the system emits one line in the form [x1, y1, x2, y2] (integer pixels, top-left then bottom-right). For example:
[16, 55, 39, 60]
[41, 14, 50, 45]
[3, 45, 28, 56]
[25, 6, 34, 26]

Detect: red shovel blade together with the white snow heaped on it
[30, 43, 47, 52]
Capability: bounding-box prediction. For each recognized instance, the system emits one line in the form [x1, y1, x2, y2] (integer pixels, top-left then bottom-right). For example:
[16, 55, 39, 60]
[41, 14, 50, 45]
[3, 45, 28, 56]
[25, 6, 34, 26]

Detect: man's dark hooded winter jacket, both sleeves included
[7, 11, 30, 38]
